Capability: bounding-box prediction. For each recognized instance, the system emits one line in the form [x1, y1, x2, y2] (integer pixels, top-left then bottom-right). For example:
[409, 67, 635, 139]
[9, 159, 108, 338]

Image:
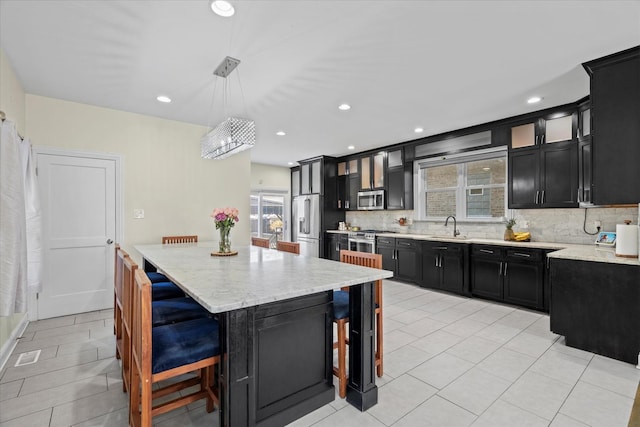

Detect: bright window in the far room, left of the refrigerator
[250, 192, 289, 240]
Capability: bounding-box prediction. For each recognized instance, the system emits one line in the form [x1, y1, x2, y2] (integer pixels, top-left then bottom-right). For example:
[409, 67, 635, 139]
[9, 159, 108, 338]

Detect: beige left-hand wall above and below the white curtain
[0, 49, 26, 363]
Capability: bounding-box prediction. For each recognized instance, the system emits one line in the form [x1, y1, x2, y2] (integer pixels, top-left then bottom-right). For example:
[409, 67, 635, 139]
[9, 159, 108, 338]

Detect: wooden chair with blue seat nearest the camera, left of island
[129, 269, 220, 427]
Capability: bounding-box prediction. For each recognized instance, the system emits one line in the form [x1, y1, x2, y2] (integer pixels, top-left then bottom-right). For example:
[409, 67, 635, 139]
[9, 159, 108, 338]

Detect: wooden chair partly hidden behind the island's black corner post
[333, 250, 383, 398]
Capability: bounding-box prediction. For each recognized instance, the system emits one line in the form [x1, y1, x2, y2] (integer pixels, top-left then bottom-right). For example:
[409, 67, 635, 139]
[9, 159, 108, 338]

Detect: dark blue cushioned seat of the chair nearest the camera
[151, 317, 220, 374]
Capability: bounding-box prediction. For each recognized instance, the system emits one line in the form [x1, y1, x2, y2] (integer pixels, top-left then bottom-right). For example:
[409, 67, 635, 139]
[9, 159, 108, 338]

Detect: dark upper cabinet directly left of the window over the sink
[385, 147, 414, 210]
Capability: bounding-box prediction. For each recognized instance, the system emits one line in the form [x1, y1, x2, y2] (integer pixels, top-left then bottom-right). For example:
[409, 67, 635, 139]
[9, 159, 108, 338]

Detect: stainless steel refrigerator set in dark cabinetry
[291, 194, 321, 257]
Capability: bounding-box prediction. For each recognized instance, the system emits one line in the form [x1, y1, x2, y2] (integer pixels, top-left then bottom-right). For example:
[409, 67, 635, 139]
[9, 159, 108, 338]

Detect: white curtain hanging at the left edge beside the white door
[0, 120, 41, 316]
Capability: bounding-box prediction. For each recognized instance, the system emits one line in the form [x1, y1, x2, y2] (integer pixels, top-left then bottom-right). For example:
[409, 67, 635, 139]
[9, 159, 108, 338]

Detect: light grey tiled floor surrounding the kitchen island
[0, 281, 640, 427]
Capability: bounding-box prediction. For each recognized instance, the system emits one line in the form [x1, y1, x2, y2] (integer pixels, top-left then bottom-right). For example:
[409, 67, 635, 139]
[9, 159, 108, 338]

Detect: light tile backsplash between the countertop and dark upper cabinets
[346, 207, 638, 244]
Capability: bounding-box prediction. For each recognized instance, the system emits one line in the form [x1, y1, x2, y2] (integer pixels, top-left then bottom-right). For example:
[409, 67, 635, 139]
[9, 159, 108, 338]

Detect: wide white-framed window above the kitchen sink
[416, 149, 507, 221]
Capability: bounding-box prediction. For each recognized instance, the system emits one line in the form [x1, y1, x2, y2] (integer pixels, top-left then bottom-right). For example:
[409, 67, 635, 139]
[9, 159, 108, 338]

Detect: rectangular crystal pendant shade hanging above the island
[200, 117, 256, 160]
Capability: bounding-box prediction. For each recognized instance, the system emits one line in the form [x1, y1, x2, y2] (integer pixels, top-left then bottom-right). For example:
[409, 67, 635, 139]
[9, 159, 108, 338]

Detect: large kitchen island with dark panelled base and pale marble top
[135, 242, 392, 426]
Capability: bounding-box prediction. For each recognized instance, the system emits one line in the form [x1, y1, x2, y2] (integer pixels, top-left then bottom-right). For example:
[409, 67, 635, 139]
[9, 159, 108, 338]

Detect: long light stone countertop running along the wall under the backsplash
[328, 230, 640, 265]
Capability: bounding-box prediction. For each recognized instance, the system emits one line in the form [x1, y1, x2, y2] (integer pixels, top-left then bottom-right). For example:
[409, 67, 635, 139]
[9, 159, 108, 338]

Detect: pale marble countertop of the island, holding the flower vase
[135, 242, 393, 313]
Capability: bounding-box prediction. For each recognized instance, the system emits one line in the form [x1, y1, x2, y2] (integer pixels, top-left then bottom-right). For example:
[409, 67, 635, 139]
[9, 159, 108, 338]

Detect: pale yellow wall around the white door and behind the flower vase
[26, 95, 251, 260]
